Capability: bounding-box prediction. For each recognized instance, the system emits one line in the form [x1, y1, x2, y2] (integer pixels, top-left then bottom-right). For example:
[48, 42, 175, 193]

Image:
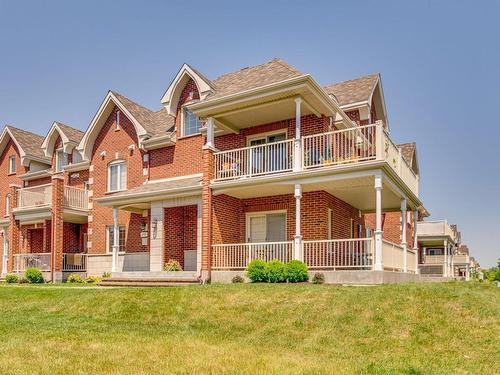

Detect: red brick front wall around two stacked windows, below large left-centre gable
[88, 107, 148, 254]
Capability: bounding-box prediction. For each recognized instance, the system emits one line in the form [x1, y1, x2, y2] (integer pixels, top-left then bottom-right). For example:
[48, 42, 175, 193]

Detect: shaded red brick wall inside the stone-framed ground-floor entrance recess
[164, 205, 197, 267]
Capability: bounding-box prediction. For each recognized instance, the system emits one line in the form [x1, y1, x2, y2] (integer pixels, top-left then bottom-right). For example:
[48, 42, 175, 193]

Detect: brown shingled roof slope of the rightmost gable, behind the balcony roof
[324, 74, 380, 106]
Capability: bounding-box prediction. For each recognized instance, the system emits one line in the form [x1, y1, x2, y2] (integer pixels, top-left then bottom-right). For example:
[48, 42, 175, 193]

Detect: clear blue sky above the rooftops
[0, 0, 500, 266]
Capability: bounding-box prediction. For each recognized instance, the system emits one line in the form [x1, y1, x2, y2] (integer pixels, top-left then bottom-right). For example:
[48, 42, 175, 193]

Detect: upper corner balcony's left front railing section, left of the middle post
[215, 139, 294, 180]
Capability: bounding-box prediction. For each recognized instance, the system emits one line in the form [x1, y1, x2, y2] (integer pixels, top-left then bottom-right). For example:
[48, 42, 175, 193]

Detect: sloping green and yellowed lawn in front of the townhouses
[0, 282, 500, 374]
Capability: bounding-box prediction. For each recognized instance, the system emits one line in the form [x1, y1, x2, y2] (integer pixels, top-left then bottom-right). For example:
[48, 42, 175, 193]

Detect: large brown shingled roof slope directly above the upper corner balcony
[207, 59, 304, 99]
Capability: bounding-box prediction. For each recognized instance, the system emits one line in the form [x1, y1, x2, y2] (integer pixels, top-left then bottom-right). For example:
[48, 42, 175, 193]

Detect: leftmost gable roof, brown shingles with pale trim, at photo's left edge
[0, 125, 50, 165]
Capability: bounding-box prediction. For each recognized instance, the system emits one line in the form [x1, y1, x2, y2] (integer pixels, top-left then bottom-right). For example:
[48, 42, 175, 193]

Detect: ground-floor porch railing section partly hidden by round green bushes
[212, 241, 293, 270]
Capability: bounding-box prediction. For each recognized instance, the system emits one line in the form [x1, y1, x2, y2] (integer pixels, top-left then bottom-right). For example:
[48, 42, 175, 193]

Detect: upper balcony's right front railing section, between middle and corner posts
[302, 125, 377, 169]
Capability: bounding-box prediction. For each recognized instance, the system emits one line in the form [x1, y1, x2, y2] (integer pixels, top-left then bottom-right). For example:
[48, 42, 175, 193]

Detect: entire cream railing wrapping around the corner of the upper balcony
[214, 122, 419, 197]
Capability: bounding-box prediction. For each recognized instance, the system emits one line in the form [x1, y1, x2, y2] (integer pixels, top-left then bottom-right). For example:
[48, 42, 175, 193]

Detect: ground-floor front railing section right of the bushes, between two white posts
[303, 238, 373, 270]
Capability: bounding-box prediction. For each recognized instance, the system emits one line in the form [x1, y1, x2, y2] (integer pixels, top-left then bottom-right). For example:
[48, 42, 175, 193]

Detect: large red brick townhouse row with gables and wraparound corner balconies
[0, 59, 450, 283]
